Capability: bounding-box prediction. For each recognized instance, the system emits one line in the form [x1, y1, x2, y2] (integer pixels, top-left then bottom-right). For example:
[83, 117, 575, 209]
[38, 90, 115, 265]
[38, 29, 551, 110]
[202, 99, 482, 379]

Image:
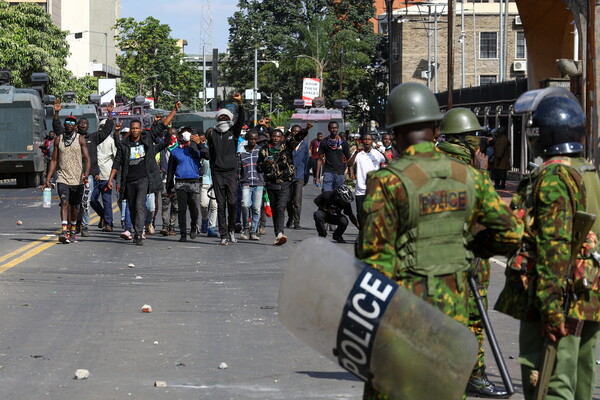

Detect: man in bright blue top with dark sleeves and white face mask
[167, 127, 208, 242]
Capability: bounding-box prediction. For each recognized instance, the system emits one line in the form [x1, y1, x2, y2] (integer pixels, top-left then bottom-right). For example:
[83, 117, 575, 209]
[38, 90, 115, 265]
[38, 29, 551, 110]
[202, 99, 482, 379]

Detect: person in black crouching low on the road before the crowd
[313, 185, 359, 243]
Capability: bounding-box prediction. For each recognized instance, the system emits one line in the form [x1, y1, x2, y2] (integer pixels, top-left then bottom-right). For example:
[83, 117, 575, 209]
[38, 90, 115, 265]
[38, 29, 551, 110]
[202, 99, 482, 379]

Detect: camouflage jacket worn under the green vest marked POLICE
[356, 142, 523, 324]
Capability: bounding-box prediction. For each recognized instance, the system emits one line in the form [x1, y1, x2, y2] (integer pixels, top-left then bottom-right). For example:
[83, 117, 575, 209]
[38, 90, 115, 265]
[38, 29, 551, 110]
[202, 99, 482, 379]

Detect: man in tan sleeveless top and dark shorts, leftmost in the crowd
[42, 99, 94, 244]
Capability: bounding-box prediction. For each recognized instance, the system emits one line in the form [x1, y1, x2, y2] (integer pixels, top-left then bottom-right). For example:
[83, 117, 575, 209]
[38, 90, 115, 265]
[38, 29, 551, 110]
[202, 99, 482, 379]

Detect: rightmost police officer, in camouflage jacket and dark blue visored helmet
[495, 88, 600, 400]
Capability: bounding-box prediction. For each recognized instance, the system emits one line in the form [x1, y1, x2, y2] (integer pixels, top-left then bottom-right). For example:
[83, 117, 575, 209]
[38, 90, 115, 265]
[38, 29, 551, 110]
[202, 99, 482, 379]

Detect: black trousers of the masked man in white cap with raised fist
[212, 171, 239, 237]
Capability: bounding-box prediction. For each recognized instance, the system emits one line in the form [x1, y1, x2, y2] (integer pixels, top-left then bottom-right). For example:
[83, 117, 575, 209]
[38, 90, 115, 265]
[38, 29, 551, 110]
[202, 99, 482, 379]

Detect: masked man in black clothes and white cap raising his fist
[206, 93, 244, 246]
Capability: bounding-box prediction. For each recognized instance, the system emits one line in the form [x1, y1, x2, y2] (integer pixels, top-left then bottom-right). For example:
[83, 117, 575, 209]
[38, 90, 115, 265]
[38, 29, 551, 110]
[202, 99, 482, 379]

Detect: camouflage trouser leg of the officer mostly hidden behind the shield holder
[469, 260, 490, 379]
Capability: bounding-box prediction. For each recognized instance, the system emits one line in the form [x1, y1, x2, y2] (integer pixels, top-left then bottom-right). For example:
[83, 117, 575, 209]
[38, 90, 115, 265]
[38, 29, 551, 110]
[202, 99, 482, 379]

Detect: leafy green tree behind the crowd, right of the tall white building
[115, 17, 202, 108]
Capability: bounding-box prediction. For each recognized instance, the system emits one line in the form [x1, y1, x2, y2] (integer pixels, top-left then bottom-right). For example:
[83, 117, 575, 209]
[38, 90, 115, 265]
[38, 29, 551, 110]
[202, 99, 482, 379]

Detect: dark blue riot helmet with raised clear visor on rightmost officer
[515, 87, 586, 157]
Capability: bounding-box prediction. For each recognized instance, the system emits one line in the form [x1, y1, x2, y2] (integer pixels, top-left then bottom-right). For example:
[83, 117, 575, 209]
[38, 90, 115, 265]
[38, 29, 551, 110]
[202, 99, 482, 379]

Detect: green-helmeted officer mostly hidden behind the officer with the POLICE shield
[438, 108, 508, 398]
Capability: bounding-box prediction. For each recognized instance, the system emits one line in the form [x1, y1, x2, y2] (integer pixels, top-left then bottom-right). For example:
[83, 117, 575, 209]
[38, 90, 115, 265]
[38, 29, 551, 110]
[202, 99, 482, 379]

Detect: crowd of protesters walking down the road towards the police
[43, 93, 494, 246]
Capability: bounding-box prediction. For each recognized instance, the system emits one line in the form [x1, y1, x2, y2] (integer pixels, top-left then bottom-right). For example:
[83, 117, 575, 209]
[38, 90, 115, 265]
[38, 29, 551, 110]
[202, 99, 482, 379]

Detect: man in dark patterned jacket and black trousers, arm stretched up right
[257, 122, 313, 246]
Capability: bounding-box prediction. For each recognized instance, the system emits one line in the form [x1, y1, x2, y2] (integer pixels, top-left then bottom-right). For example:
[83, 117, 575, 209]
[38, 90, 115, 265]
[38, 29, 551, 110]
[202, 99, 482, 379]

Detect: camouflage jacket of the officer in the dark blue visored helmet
[494, 157, 600, 325]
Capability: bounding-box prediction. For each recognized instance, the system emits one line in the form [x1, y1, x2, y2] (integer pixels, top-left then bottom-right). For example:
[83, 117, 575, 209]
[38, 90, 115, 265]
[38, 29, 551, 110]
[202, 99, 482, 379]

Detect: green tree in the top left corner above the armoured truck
[0, 0, 71, 93]
